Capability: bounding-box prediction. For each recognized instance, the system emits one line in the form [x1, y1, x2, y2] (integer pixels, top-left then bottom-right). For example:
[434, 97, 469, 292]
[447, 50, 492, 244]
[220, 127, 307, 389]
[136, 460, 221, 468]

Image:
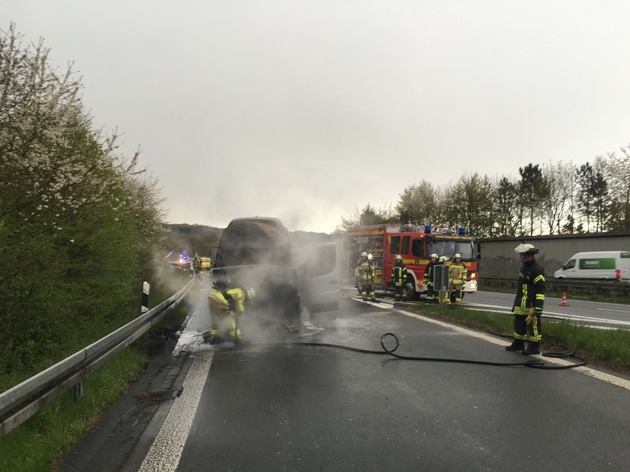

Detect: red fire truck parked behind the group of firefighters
[346, 225, 478, 299]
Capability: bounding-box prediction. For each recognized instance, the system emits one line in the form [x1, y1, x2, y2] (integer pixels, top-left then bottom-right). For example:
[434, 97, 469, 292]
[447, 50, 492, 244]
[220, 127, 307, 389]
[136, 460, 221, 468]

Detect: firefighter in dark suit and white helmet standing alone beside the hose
[505, 243, 545, 356]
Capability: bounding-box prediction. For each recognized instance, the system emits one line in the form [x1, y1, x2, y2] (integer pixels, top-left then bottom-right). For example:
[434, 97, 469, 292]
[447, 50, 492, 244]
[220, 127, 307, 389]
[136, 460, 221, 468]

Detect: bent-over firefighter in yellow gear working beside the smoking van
[208, 276, 256, 344]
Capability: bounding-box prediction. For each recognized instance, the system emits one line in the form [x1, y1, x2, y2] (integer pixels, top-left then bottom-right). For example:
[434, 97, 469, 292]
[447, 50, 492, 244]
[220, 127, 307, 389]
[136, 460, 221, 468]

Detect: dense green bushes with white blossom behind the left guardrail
[0, 25, 163, 374]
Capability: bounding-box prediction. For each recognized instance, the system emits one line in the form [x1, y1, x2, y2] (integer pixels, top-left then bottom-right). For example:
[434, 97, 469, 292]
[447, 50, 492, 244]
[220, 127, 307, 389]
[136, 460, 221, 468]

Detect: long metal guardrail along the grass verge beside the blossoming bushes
[0, 278, 195, 437]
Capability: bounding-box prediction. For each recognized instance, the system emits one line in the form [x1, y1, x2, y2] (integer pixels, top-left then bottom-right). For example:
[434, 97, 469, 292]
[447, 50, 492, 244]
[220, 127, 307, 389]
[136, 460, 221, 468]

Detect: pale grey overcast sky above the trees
[0, 0, 630, 232]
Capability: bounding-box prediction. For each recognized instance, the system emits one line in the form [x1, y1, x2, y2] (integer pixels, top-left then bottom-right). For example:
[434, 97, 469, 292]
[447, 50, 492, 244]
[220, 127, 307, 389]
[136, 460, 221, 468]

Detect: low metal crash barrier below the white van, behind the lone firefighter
[479, 276, 630, 296]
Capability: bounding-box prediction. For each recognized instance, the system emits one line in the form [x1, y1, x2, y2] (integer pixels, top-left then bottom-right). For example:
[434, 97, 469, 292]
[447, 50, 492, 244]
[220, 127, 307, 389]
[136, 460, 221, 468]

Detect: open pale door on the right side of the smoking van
[293, 243, 341, 321]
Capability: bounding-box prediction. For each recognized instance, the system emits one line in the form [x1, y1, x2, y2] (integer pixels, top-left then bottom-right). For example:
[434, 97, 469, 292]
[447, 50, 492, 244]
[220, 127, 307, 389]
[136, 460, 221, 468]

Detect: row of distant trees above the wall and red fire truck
[340, 145, 630, 238]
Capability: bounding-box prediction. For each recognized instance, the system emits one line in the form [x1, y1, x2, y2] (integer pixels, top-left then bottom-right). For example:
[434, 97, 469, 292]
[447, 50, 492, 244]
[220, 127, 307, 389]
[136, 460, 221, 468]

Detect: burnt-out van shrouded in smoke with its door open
[212, 217, 341, 325]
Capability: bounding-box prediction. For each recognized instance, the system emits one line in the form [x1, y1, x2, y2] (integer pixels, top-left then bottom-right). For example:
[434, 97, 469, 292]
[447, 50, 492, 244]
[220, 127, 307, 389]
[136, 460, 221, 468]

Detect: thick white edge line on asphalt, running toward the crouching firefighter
[138, 350, 214, 472]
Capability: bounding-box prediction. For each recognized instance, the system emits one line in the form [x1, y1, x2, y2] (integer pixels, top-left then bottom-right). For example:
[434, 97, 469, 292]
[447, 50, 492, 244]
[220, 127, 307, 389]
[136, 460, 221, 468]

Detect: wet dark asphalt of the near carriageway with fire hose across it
[62, 291, 630, 472]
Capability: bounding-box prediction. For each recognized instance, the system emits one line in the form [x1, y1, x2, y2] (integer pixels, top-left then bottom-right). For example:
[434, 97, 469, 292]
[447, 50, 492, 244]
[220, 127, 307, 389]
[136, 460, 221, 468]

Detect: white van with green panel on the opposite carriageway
[553, 251, 630, 280]
